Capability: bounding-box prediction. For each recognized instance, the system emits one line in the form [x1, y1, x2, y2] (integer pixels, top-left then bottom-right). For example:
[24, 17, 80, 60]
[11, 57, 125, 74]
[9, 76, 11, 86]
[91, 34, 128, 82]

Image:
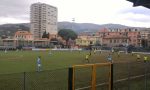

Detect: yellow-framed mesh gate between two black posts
[69, 63, 112, 90]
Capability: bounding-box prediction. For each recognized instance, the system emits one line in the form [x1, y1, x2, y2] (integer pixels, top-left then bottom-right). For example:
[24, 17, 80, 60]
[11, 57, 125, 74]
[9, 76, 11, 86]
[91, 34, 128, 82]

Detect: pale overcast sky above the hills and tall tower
[0, 0, 150, 27]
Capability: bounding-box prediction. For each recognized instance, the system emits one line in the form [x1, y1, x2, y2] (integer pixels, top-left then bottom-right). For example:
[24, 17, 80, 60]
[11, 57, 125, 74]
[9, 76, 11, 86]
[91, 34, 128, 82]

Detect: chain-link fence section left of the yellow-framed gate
[0, 69, 68, 90]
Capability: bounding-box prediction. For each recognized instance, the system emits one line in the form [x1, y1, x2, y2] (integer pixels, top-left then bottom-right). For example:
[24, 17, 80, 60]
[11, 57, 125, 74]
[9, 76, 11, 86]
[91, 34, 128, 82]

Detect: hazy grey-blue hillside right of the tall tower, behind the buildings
[58, 22, 129, 33]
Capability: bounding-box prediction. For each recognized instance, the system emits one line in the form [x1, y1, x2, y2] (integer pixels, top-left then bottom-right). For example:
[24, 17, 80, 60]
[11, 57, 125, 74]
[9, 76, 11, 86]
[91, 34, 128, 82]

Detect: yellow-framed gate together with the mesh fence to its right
[70, 61, 150, 90]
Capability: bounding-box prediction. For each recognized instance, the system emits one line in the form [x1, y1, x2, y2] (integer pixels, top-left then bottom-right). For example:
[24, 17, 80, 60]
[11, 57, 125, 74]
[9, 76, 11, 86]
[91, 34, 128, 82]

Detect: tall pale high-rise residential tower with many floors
[30, 3, 57, 39]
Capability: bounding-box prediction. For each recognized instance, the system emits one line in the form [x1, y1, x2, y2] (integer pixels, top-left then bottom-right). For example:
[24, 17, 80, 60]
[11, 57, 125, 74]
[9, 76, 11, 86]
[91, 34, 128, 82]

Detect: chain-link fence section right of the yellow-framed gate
[113, 62, 150, 90]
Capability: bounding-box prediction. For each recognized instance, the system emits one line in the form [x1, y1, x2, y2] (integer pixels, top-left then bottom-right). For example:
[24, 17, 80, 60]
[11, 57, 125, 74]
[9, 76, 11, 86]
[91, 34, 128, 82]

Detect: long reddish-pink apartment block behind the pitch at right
[103, 28, 140, 46]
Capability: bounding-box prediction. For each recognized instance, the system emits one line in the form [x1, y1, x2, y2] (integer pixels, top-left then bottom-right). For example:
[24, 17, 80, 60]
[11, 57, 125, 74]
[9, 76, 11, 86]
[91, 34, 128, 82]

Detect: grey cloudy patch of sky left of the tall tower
[0, 0, 30, 24]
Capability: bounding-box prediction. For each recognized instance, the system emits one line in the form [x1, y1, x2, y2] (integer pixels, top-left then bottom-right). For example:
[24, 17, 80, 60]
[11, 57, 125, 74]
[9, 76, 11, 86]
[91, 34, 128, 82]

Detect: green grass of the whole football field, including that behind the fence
[0, 51, 150, 90]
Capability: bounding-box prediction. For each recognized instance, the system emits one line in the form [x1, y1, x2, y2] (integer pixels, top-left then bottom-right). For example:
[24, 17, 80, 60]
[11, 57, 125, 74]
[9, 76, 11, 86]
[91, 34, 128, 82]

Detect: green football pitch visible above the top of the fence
[0, 51, 143, 74]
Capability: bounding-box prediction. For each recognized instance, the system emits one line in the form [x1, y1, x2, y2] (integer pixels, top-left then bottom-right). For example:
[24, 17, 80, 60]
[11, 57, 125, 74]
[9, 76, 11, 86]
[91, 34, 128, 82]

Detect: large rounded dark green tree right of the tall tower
[58, 29, 77, 42]
